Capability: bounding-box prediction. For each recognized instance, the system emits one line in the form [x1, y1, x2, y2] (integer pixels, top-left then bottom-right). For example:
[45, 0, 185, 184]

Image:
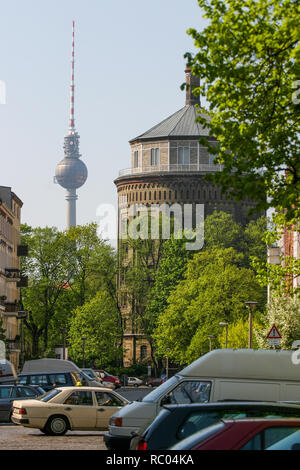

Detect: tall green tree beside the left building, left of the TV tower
[22, 225, 74, 357]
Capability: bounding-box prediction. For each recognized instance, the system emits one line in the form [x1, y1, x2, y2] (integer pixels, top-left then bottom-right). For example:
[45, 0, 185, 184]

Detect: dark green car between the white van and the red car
[130, 402, 300, 450]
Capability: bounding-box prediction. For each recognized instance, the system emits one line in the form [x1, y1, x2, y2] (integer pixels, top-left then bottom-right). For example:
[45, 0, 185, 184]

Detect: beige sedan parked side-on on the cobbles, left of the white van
[11, 387, 129, 436]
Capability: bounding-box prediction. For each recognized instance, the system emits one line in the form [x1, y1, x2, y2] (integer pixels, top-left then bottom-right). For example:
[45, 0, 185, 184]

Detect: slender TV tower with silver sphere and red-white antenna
[55, 21, 87, 230]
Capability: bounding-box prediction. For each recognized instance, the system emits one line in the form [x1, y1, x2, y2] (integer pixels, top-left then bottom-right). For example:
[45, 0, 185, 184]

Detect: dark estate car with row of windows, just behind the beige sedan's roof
[18, 371, 84, 392]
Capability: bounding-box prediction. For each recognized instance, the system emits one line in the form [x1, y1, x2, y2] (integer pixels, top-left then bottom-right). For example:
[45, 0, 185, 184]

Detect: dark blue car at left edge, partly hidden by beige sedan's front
[0, 384, 45, 423]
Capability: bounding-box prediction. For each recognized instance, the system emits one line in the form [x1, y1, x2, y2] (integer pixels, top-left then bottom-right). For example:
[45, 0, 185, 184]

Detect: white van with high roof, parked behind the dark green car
[104, 349, 300, 450]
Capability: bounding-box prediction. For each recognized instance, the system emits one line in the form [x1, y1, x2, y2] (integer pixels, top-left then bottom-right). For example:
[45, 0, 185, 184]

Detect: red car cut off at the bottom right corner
[170, 418, 300, 450]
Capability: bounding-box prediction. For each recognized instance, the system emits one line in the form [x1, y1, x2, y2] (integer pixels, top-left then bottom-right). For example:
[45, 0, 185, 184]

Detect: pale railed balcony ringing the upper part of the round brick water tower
[119, 163, 223, 177]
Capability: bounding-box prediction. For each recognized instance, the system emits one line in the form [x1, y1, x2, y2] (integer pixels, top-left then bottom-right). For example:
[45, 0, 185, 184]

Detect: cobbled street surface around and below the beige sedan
[0, 387, 152, 450]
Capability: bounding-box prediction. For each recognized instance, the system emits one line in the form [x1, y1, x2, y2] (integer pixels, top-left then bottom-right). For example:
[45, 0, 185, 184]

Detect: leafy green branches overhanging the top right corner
[186, 0, 300, 222]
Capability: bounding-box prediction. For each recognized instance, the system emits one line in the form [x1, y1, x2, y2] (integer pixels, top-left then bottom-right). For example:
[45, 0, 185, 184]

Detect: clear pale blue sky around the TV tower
[0, 0, 204, 229]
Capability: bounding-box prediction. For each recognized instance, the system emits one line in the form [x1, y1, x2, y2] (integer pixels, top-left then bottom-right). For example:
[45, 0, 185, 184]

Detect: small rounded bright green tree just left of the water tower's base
[68, 290, 122, 367]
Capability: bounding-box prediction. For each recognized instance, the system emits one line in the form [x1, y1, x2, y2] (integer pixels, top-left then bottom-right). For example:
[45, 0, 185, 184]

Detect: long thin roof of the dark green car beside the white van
[164, 401, 300, 411]
